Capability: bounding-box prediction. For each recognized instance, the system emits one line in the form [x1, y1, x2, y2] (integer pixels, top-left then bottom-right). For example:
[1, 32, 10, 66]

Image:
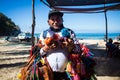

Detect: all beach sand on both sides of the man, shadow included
[0, 40, 120, 80]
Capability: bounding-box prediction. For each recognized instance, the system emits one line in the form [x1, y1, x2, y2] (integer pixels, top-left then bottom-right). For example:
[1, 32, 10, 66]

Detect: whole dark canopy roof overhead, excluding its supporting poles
[41, 0, 120, 12]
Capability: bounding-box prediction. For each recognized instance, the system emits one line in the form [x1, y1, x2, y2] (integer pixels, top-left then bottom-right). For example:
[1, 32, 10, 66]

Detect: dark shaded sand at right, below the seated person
[91, 49, 120, 76]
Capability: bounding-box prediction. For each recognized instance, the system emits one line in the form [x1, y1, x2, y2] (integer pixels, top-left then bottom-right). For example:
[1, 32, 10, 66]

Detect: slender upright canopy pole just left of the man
[32, 0, 35, 46]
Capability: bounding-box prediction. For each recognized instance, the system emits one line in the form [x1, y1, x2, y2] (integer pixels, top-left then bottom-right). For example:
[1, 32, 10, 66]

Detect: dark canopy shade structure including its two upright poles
[32, 0, 120, 46]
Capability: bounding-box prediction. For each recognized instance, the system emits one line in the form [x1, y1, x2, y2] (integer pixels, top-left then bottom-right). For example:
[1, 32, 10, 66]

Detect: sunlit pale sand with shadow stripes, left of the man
[0, 40, 31, 80]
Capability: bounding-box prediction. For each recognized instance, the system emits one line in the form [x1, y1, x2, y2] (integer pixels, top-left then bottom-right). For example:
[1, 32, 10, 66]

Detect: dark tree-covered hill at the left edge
[0, 12, 21, 36]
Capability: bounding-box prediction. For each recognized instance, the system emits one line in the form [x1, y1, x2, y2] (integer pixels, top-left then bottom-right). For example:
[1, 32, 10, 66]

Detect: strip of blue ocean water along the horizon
[35, 33, 120, 39]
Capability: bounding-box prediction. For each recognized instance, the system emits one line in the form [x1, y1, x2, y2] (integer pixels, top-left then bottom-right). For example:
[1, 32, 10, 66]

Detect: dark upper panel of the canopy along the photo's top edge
[45, 0, 120, 6]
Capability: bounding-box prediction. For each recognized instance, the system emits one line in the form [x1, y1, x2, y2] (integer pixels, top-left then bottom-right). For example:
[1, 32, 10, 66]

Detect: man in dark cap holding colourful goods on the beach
[40, 10, 75, 80]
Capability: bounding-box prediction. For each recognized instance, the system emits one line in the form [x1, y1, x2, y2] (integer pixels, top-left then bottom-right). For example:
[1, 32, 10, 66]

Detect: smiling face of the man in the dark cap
[48, 15, 63, 29]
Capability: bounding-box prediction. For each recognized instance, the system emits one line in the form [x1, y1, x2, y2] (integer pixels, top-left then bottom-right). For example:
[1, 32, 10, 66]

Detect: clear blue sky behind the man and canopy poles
[0, 0, 120, 33]
